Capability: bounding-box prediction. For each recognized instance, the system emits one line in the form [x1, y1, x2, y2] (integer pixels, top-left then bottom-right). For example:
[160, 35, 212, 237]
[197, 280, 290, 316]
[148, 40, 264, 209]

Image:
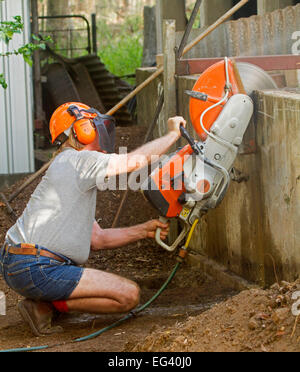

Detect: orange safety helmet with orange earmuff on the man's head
[50, 102, 97, 145]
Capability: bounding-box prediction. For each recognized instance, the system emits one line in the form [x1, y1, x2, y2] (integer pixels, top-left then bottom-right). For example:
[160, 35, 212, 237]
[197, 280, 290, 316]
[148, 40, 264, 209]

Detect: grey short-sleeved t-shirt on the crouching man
[6, 148, 110, 265]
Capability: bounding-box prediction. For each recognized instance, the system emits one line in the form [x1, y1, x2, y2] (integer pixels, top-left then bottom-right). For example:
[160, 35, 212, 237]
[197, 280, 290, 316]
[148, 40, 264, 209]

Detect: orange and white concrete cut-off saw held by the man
[142, 58, 277, 252]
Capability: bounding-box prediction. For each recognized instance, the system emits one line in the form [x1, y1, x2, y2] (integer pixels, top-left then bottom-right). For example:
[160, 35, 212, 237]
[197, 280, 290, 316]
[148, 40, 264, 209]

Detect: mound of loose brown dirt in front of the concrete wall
[127, 280, 300, 352]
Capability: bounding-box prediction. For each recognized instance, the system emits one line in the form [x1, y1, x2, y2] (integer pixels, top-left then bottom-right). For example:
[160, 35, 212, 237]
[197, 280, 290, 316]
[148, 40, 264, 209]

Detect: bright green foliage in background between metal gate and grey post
[98, 16, 143, 83]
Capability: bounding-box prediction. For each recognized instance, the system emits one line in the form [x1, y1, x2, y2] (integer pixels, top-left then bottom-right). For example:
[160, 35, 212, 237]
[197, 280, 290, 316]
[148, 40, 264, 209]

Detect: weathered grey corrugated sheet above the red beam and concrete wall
[177, 4, 300, 58]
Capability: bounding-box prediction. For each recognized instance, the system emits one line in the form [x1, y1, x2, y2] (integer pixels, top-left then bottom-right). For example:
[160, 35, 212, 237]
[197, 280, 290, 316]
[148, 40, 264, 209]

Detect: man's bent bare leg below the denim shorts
[67, 269, 140, 314]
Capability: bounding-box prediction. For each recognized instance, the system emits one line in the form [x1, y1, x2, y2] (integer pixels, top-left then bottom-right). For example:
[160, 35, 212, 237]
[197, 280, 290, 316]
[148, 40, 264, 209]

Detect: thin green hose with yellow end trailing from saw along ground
[0, 220, 199, 353]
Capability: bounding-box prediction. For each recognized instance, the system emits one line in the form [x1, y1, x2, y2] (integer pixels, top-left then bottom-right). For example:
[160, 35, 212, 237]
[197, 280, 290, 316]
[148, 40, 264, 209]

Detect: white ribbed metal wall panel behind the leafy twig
[0, 0, 34, 174]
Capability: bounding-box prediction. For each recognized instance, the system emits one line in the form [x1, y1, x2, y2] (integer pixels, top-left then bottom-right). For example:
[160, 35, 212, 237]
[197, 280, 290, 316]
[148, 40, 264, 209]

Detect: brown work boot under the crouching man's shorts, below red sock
[18, 299, 63, 337]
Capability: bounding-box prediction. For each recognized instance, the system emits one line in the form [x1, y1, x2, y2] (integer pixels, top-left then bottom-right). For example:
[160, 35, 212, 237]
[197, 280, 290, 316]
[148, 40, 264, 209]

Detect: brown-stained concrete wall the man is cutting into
[138, 70, 300, 285]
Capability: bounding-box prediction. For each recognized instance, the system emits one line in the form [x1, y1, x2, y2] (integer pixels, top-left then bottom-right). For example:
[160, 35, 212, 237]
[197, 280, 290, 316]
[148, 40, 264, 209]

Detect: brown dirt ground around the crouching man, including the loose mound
[0, 127, 300, 352]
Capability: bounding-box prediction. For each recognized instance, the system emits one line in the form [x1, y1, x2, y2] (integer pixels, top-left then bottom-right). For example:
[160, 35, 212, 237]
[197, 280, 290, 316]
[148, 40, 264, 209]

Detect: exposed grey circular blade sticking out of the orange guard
[236, 62, 278, 96]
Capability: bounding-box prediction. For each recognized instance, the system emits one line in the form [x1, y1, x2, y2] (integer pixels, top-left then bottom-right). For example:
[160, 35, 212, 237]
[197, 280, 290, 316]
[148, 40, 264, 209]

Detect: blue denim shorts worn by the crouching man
[0, 245, 84, 302]
